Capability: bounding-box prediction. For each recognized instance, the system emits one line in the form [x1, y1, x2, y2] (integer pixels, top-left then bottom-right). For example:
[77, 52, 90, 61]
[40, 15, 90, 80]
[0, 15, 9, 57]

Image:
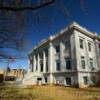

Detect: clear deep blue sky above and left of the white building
[0, 0, 100, 69]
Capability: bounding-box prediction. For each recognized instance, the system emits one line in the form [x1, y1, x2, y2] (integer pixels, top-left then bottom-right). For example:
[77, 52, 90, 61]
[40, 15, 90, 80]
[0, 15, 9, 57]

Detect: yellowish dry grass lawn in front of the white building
[0, 86, 100, 100]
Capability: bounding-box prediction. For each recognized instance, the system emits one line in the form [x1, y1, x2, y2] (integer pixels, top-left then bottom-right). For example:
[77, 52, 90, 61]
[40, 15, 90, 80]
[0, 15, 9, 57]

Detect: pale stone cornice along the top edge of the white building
[28, 22, 100, 55]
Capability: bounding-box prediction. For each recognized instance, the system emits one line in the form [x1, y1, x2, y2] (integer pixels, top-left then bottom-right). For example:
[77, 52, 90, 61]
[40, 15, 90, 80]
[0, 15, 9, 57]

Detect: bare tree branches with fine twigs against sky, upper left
[0, 0, 54, 59]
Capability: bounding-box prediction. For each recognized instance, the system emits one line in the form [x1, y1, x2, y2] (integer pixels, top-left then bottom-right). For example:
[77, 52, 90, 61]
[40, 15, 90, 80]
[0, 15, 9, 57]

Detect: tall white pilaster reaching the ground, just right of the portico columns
[49, 43, 53, 84]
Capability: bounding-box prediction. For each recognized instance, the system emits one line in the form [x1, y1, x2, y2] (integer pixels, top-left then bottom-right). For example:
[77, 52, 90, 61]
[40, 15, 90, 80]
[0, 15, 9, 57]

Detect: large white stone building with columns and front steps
[24, 22, 100, 87]
